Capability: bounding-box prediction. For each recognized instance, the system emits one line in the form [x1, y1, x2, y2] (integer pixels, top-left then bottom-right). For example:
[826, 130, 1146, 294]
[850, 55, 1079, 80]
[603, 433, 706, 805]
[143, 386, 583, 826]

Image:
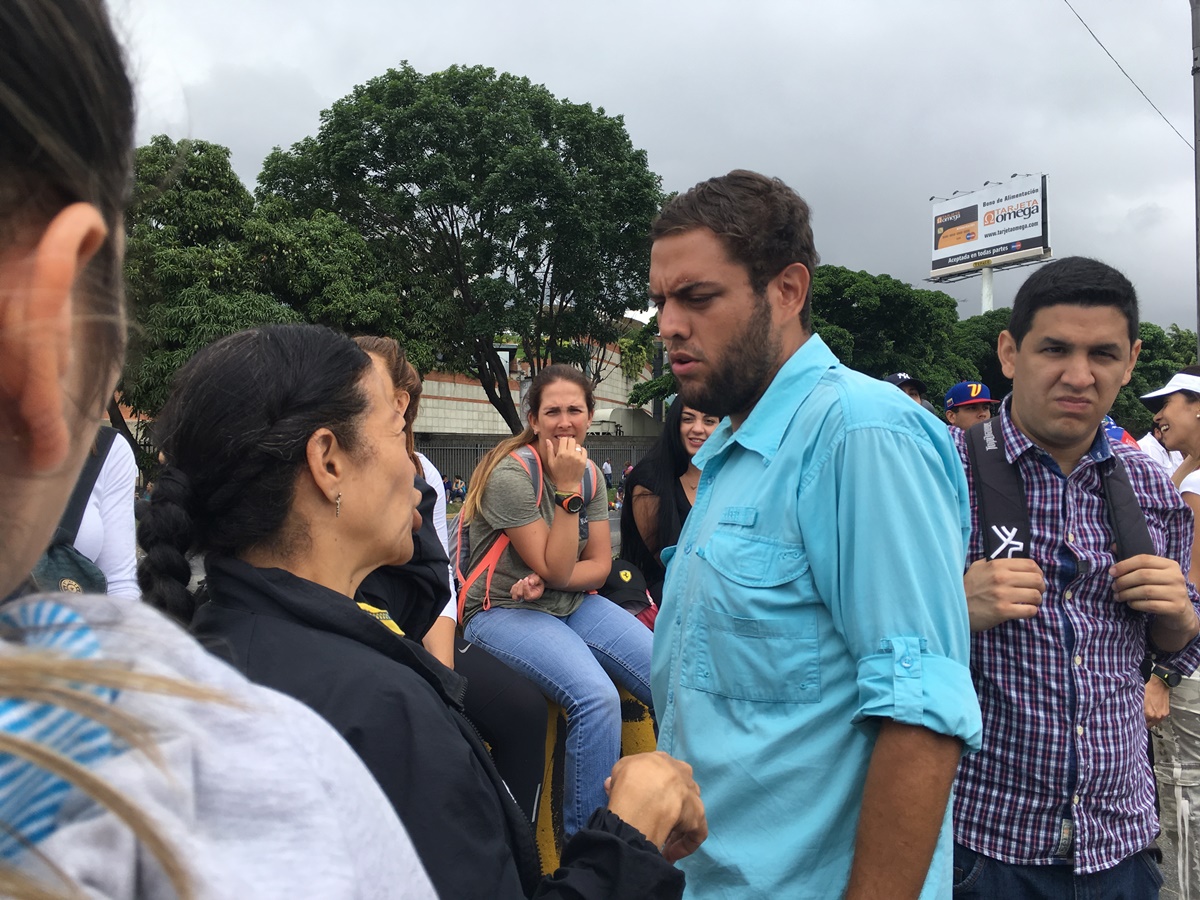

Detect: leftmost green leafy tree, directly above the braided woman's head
[120, 136, 436, 424]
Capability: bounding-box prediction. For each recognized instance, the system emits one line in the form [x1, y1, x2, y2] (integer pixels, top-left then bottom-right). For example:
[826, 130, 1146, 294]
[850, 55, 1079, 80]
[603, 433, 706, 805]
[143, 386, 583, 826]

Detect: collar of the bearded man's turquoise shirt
[694, 334, 838, 469]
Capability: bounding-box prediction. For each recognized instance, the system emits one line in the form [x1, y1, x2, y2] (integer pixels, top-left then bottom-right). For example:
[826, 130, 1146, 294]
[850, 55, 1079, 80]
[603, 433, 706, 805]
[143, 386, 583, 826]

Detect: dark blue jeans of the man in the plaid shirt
[954, 844, 1163, 900]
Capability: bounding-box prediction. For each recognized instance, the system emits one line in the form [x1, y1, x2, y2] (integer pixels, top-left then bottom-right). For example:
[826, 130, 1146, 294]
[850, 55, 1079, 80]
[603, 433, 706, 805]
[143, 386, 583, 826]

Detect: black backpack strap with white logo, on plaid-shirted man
[966, 419, 1032, 559]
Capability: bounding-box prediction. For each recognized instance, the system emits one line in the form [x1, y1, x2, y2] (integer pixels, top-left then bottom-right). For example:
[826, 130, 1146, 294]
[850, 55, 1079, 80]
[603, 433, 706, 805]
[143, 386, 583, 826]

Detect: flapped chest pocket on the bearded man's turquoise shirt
[680, 530, 821, 703]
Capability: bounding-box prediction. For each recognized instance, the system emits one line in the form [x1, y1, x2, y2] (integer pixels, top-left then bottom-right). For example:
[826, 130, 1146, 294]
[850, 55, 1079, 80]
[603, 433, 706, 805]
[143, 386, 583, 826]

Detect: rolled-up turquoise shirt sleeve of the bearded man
[800, 420, 983, 751]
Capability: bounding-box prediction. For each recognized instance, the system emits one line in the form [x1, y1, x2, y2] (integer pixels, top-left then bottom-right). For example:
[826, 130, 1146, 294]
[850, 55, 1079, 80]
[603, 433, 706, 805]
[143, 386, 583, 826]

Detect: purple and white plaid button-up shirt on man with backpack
[953, 401, 1200, 874]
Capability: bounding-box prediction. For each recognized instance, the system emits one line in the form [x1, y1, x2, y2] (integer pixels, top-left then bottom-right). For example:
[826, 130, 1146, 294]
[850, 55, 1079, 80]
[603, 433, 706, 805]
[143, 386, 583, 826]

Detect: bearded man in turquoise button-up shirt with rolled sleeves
[650, 172, 980, 900]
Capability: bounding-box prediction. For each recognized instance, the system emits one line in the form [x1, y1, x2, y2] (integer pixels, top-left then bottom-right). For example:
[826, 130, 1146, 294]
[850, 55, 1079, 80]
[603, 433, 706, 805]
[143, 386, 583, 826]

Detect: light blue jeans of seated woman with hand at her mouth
[463, 594, 653, 835]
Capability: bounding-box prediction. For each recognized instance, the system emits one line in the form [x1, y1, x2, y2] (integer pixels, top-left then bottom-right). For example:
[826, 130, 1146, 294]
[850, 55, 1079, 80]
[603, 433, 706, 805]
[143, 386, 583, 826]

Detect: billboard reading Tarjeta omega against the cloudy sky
[929, 175, 1050, 278]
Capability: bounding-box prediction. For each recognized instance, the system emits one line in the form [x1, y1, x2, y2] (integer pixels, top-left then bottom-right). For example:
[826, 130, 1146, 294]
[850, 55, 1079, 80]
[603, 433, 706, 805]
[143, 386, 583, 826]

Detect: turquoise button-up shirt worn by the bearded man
[652, 335, 982, 900]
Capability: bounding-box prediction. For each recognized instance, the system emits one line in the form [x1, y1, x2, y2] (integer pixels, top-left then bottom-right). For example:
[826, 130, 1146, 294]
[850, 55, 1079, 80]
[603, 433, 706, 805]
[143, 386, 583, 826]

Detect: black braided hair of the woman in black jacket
[138, 325, 371, 622]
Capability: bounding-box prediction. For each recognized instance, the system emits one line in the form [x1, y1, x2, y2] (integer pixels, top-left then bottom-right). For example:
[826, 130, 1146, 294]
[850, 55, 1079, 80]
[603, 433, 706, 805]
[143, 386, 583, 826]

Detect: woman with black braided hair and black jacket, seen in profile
[138, 325, 707, 900]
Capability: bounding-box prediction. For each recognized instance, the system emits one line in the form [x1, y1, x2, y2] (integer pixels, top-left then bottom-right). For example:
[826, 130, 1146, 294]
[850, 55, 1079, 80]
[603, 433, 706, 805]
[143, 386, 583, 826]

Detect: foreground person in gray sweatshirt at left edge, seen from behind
[0, 0, 434, 899]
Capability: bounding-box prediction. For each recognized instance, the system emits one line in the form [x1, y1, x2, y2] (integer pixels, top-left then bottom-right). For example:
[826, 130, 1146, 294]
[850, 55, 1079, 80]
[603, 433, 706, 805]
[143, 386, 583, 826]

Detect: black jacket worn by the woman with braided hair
[192, 559, 684, 900]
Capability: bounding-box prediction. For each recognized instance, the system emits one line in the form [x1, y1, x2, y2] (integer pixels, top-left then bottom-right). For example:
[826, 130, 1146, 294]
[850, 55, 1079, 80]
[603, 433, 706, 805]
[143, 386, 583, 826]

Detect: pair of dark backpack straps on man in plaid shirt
[966, 419, 1156, 560]
